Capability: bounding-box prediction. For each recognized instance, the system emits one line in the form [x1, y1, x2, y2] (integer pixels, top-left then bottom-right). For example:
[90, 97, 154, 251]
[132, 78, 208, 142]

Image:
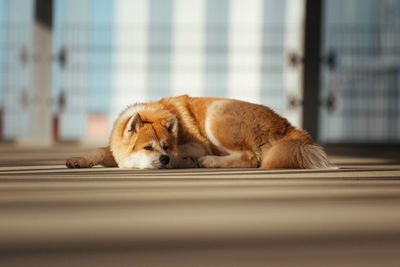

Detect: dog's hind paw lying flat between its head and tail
[199, 151, 258, 168]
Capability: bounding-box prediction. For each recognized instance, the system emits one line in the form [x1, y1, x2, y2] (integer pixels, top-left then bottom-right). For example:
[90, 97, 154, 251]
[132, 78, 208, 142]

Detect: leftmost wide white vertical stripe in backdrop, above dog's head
[111, 0, 151, 119]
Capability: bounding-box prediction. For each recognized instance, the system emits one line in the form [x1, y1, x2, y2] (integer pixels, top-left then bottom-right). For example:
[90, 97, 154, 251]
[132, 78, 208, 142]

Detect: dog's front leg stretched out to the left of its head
[65, 147, 117, 168]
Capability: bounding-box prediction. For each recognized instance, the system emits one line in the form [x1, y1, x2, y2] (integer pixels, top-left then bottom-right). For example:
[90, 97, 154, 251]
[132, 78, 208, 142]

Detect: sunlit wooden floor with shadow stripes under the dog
[0, 144, 400, 266]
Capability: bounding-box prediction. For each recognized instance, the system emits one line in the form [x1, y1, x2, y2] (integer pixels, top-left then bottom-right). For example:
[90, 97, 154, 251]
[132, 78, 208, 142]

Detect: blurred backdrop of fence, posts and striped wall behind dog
[0, 0, 400, 144]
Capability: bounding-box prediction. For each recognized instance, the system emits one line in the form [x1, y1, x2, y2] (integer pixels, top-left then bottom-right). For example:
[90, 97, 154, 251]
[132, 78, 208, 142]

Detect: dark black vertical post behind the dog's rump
[303, 0, 322, 140]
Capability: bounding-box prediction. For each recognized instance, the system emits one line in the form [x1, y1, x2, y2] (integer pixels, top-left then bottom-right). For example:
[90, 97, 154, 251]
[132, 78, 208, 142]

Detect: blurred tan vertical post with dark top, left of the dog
[31, 0, 53, 143]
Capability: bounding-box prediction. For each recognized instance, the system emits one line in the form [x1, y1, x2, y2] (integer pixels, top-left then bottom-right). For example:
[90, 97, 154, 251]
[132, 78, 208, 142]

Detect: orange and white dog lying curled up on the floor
[66, 95, 333, 169]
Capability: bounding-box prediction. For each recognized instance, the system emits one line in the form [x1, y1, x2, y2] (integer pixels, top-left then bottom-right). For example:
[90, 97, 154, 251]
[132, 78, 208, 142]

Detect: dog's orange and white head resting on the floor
[110, 111, 179, 169]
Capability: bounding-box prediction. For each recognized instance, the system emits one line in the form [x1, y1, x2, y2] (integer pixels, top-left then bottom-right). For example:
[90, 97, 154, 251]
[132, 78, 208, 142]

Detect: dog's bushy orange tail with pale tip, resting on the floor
[261, 129, 336, 169]
